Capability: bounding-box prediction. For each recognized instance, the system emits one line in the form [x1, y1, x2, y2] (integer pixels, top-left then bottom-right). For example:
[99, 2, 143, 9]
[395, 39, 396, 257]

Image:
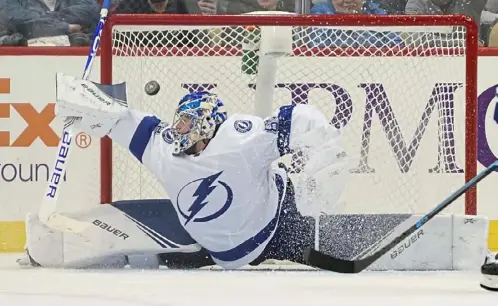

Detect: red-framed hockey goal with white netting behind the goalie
[101, 15, 477, 214]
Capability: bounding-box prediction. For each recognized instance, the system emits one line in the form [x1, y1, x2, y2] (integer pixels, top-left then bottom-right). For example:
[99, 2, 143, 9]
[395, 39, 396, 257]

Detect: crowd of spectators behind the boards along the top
[0, 0, 498, 46]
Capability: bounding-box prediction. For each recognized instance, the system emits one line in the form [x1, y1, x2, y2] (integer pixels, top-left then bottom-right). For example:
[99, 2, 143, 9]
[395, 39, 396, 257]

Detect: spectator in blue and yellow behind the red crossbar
[309, 0, 402, 47]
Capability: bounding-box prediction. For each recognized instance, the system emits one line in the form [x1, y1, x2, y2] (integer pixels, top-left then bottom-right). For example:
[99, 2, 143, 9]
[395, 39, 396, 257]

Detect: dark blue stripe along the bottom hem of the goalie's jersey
[208, 174, 285, 261]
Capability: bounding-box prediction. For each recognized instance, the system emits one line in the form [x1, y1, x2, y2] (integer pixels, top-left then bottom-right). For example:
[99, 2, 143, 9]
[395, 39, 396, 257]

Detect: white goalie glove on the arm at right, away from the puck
[291, 106, 349, 216]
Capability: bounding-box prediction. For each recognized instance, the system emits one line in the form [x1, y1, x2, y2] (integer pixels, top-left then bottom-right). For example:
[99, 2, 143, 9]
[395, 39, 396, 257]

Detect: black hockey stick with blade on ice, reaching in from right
[304, 161, 498, 273]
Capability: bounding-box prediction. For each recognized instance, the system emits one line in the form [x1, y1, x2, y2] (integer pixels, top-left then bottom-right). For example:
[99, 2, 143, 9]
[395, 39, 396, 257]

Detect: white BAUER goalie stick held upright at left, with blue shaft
[38, 0, 111, 233]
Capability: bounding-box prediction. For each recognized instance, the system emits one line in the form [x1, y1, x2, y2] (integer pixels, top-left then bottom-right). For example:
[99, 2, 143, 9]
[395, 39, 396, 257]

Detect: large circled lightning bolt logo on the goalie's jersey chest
[176, 171, 233, 225]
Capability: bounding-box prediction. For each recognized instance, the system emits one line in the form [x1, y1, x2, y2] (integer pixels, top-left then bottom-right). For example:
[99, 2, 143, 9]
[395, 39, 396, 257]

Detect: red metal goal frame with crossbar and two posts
[100, 14, 478, 215]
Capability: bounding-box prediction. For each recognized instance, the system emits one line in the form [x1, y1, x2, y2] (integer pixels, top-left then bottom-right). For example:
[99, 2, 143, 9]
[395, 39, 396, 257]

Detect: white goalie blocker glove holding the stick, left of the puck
[55, 73, 128, 137]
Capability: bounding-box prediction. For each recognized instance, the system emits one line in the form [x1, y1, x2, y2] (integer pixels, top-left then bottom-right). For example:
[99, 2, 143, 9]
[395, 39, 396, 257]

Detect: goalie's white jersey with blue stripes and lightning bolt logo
[110, 105, 339, 268]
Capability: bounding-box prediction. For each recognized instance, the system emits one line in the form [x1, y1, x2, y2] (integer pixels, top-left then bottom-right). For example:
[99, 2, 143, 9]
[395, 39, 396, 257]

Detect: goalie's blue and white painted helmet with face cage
[172, 91, 227, 155]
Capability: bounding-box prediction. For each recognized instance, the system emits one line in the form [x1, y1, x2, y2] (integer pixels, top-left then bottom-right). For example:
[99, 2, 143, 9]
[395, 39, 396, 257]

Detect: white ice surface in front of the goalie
[0, 255, 498, 306]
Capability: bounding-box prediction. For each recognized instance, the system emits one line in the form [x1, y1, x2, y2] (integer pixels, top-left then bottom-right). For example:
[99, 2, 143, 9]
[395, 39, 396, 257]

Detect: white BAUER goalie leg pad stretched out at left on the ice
[26, 201, 201, 269]
